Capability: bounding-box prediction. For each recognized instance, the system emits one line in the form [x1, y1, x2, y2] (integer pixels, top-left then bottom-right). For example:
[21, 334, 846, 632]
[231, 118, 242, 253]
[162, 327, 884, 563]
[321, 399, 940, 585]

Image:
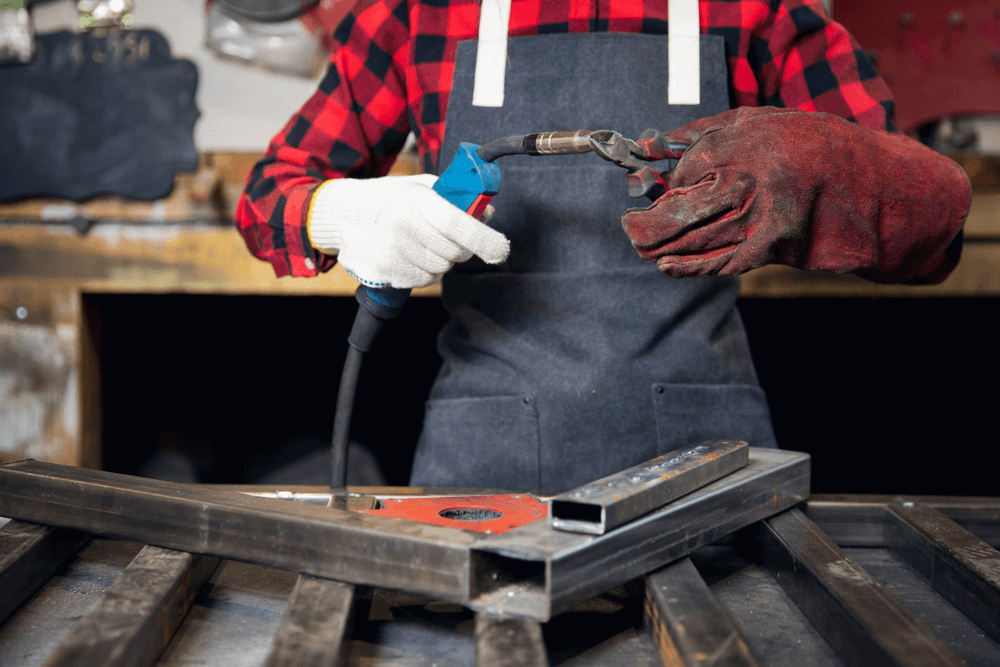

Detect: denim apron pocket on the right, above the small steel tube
[653, 383, 778, 454]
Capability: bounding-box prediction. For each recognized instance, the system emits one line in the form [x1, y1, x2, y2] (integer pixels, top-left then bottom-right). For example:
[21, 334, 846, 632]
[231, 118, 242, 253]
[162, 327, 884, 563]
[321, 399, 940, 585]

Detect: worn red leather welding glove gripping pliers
[622, 107, 972, 282]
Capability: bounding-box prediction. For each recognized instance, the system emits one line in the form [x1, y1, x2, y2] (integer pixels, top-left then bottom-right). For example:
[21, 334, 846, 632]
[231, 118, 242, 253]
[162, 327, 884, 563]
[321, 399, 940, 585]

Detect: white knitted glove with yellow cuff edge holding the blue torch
[308, 174, 510, 289]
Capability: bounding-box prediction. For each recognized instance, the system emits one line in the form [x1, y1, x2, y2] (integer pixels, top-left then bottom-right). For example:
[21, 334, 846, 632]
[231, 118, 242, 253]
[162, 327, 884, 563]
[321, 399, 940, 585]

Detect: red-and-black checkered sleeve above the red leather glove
[702, 0, 896, 132]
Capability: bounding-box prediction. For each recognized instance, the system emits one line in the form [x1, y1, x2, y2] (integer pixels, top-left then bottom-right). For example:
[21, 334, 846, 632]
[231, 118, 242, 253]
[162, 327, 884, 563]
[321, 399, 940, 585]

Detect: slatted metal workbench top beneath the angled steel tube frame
[0, 470, 1000, 667]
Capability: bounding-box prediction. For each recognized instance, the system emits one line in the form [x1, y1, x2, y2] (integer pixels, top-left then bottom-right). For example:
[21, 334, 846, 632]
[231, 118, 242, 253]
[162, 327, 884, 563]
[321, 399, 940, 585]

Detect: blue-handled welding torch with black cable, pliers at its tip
[330, 130, 688, 490]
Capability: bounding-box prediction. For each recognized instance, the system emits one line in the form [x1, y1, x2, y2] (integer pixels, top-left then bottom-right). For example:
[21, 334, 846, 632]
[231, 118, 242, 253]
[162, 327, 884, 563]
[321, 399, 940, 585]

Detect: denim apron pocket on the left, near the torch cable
[410, 396, 541, 489]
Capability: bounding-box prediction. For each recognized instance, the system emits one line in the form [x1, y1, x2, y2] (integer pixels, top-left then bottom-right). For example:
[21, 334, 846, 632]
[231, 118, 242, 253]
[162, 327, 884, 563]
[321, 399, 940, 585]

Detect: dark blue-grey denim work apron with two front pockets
[410, 33, 775, 489]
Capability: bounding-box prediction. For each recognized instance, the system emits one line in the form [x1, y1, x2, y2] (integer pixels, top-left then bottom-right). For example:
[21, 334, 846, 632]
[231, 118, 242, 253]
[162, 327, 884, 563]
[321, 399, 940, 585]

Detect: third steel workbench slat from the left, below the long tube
[264, 574, 355, 667]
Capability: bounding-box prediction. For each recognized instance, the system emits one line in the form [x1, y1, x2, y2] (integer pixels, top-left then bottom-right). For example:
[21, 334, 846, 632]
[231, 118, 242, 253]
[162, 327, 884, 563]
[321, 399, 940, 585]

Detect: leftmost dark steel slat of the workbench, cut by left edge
[0, 521, 90, 625]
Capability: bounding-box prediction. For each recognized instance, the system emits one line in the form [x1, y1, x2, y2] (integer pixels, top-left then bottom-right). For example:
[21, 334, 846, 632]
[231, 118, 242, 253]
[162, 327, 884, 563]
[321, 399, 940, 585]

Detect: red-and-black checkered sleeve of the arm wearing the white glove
[236, 0, 409, 277]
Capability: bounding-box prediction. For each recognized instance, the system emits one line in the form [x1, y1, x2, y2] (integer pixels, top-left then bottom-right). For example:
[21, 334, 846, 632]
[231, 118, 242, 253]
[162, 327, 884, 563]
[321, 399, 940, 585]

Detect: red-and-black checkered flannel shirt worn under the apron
[236, 0, 908, 276]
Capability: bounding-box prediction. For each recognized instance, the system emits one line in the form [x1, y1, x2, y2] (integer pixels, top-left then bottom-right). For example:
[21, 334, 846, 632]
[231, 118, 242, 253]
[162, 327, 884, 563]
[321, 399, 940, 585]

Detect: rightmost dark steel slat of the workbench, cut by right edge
[885, 503, 1000, 641]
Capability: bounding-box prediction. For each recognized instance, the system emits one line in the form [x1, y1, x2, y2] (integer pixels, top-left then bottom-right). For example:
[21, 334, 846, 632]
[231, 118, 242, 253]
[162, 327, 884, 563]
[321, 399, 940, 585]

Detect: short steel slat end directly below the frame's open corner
[475, 613, 549, 667]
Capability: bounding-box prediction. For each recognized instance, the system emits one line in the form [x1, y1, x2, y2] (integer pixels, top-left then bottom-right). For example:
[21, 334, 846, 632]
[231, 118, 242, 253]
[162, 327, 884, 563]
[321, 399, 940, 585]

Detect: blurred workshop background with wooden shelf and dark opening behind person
[0, 0, 1000, 495]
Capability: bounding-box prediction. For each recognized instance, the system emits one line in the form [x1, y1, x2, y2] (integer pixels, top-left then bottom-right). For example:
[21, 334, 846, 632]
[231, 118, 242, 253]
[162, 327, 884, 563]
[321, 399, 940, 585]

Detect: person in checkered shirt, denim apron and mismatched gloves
[237, 0, 971, 488]
